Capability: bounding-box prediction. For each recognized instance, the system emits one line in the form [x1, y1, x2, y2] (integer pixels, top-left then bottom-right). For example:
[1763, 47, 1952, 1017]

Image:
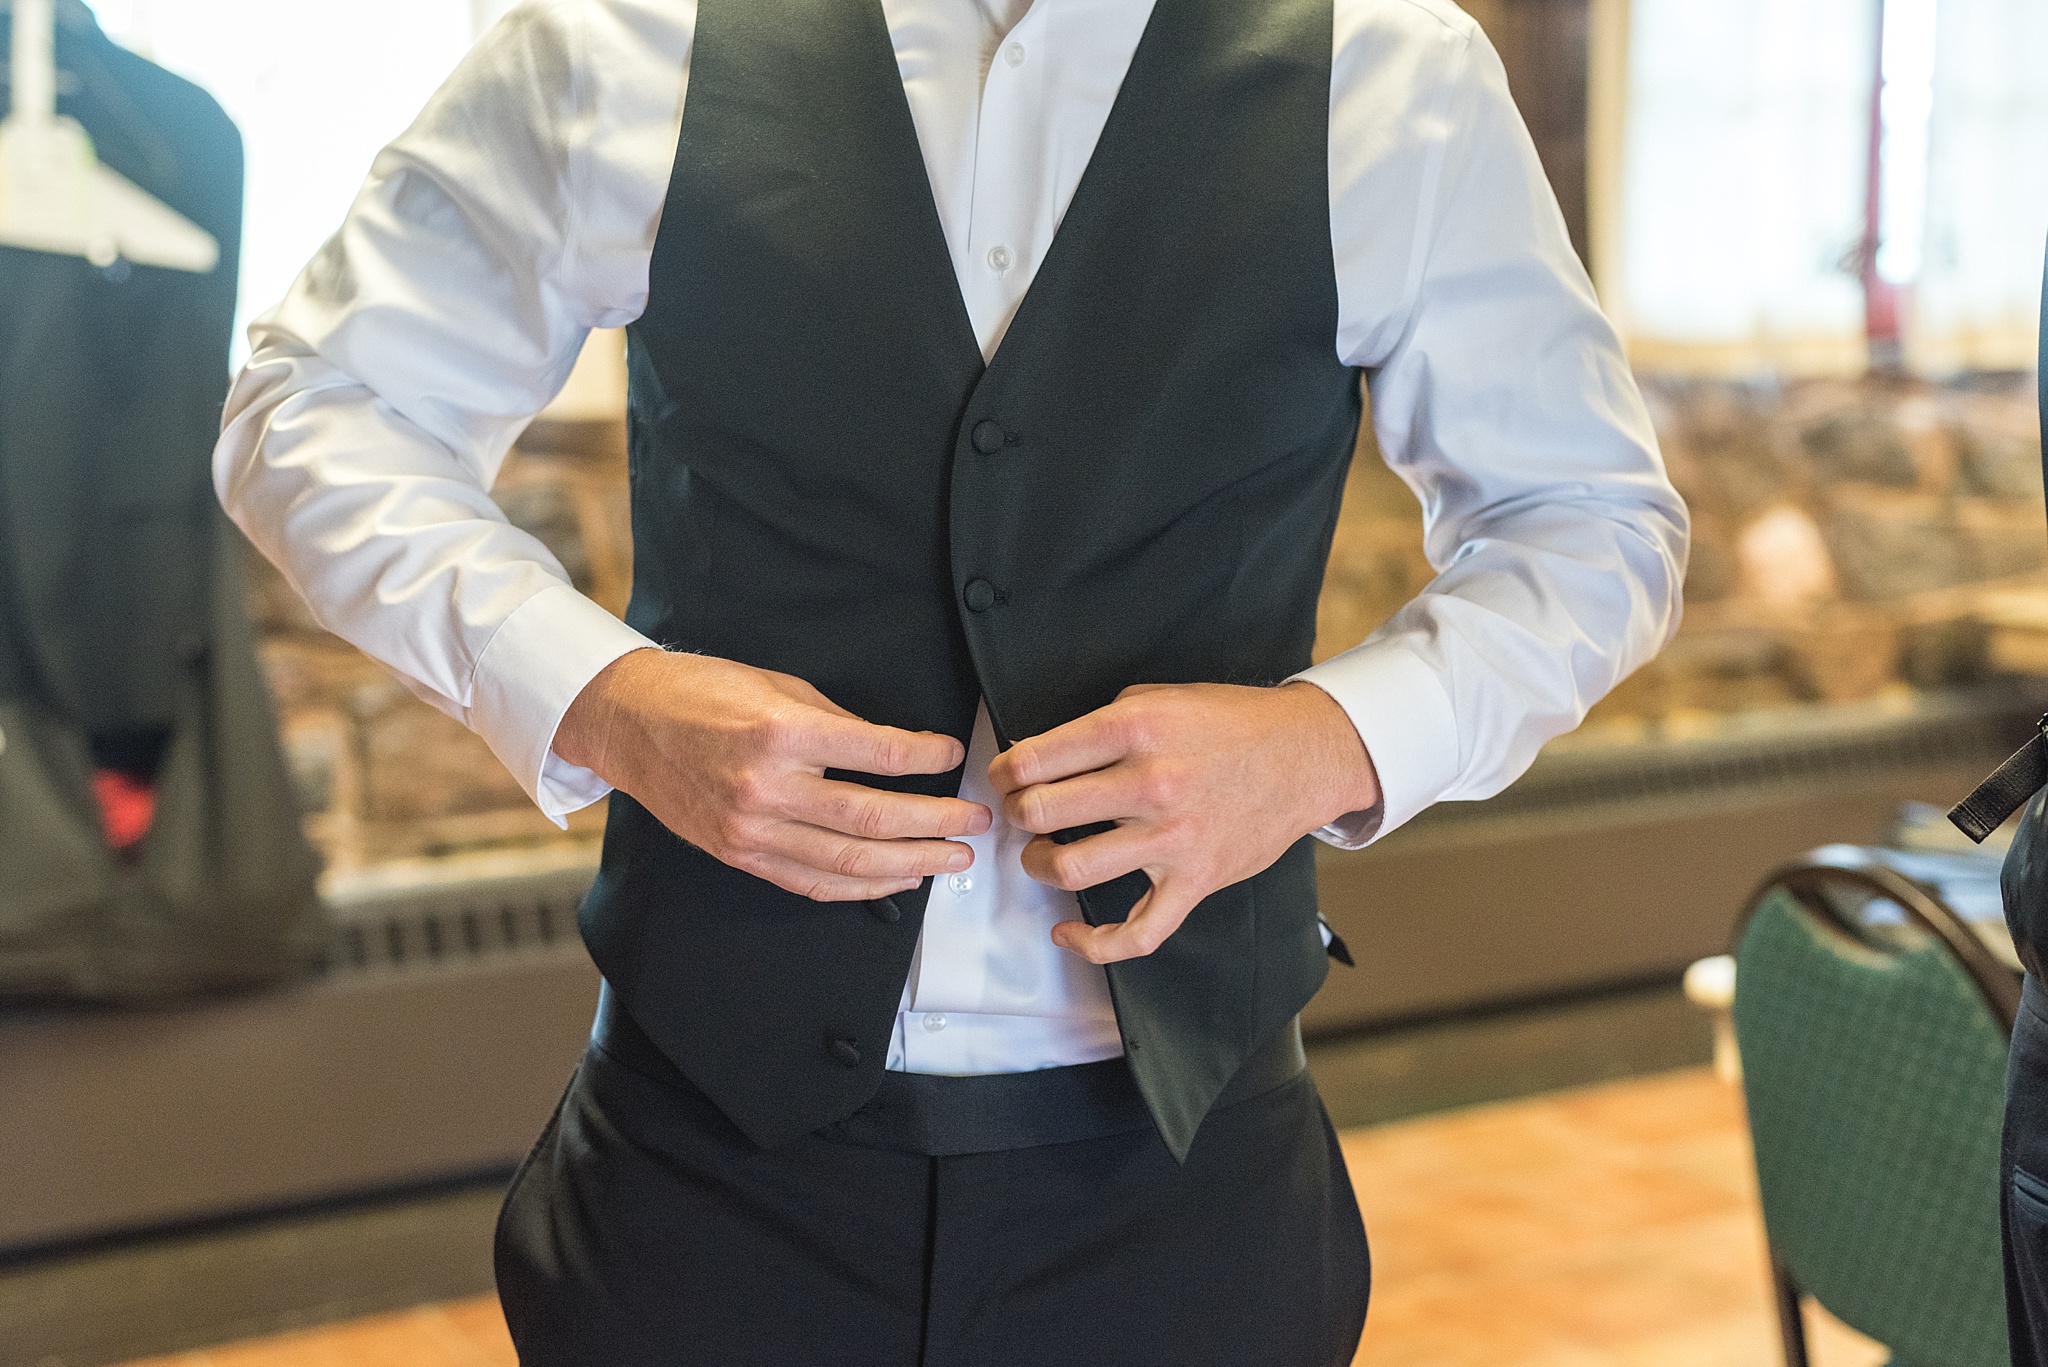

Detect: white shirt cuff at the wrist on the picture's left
[469, 584, 653, 826]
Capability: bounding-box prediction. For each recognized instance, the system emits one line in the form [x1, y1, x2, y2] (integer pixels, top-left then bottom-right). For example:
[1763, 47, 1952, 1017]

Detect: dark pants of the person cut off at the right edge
[1999, 974, 2048, 1367]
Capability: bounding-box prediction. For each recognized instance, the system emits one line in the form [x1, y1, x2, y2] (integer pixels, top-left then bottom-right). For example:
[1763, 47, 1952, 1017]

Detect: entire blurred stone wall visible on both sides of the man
[252, 370, 2048, 871]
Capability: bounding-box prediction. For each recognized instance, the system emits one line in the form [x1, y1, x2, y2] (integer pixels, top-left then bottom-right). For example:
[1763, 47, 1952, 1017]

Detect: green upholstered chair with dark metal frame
[1735, 846, 2019, 1367]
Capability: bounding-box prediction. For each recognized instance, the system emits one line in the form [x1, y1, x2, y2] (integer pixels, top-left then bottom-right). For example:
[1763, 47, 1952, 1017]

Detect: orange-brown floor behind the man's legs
[119, 1072, 1884, 1367]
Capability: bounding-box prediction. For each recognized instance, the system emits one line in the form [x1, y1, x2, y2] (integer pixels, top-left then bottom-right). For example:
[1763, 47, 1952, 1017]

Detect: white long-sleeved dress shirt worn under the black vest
[215, 0, 1686, 1074]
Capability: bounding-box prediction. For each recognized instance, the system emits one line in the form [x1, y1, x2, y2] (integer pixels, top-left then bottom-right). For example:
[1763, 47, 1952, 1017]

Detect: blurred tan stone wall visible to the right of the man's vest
[1317, 377, 2048, 742]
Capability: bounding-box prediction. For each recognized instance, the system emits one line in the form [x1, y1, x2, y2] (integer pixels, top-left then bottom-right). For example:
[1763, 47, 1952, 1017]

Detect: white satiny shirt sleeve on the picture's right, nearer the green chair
[1300, 0, 1688, 848]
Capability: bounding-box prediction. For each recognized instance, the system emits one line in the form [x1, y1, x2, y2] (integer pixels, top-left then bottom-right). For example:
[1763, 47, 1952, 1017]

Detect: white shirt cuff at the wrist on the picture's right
[1288, 641, 1458, 851]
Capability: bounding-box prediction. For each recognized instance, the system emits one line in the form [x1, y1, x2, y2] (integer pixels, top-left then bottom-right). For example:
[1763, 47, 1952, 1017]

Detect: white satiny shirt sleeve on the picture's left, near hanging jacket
[215, 0, 694, 822]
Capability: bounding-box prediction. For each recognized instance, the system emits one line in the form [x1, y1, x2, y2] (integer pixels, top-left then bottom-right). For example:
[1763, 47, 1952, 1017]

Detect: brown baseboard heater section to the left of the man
[0, 851, 598, 1252]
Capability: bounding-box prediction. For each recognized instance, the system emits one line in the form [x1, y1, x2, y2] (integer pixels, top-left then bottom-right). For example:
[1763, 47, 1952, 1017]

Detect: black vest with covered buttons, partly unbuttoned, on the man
[582, 0, 1360, 1154]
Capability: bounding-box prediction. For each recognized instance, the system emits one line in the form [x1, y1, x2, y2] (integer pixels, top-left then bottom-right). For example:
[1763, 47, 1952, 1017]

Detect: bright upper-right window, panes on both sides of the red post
[1602, 0, 2048, 375]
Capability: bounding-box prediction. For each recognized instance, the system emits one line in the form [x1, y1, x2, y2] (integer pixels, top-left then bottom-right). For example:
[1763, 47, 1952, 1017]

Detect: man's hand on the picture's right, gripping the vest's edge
[989, 682, 1380, 963]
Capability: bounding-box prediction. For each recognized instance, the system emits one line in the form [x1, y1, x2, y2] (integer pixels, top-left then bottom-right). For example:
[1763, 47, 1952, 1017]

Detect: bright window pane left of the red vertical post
[1618, 0, 1878, 362]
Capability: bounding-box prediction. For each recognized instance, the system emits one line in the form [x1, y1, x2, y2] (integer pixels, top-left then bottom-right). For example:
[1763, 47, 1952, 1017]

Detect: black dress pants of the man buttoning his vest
[498, 1004, 1370, 1367]
